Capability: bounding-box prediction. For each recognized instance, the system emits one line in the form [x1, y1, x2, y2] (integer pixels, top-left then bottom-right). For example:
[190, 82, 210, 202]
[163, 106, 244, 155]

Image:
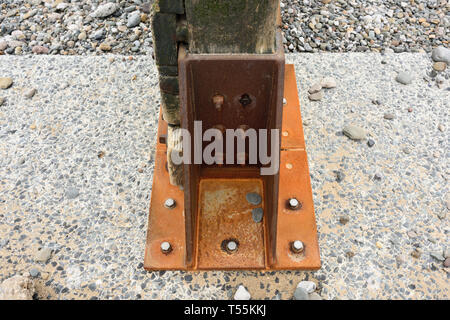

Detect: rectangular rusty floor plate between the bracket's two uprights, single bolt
[197, 179, 265, 269]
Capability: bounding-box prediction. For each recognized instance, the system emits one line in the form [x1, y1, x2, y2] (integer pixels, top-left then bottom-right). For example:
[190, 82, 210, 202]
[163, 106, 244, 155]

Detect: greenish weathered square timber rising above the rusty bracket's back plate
[185, 0, 279, 54]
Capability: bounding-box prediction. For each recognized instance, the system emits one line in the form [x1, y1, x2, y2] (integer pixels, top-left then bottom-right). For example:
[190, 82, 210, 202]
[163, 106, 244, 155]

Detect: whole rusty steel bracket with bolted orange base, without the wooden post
[144, 63, 320, 271]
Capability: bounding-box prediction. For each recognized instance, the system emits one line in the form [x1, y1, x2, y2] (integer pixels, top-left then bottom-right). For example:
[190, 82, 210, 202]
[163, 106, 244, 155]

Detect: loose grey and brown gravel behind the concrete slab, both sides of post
[0, 0, 450, 55]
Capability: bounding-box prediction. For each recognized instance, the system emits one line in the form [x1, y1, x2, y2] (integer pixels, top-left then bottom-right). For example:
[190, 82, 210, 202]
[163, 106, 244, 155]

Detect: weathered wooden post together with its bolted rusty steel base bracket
[144, 0, 320, 270]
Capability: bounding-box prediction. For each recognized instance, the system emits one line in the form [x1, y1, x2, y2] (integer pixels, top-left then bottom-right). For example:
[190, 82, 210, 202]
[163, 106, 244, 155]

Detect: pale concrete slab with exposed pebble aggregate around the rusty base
[0, 53, 450, 299]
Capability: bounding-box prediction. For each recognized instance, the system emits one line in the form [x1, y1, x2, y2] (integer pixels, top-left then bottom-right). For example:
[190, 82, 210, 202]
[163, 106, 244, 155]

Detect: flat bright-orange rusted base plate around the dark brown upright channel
[144, 65, 320, 271]
